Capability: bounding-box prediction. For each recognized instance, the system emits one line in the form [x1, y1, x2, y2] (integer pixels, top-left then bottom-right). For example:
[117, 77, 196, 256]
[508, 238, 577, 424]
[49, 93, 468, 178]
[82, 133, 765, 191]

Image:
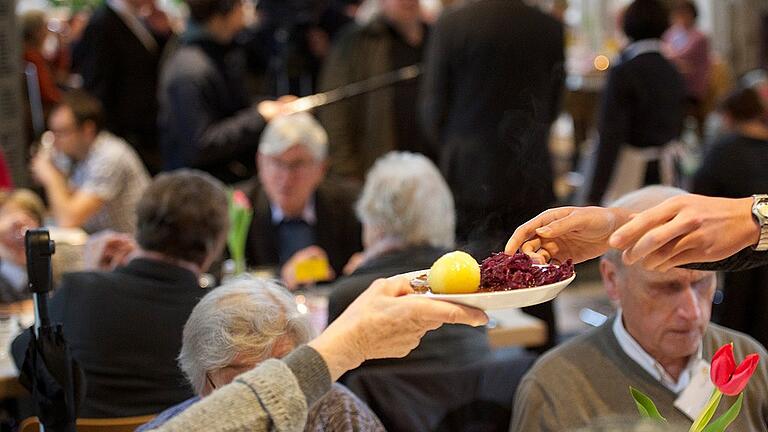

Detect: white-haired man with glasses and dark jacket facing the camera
[242, 113, 362, 289]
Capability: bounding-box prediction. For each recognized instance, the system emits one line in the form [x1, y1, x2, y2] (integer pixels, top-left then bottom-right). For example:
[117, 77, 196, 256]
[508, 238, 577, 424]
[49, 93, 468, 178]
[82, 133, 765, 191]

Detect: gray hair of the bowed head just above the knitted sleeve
[179, 278, 312, 394]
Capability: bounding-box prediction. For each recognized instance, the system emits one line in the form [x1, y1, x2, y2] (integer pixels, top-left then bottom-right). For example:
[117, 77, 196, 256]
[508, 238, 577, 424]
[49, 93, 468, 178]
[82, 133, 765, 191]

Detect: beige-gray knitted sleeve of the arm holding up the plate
[148, 346, 331, 432]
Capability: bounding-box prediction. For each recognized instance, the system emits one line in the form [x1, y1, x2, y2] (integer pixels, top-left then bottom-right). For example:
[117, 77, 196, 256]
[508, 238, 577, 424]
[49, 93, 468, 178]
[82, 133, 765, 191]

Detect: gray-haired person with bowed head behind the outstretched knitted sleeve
[139, 278, 384, 432]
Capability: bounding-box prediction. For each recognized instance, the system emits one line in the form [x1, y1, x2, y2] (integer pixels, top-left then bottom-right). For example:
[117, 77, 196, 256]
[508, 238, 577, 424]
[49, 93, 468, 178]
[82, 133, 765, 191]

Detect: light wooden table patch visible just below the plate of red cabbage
[488, 309, 547, 348]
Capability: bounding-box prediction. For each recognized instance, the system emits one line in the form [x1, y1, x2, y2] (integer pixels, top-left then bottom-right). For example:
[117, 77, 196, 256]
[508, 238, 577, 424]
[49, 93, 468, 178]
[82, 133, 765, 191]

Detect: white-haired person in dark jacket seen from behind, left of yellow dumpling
[328, 152, 490, 365]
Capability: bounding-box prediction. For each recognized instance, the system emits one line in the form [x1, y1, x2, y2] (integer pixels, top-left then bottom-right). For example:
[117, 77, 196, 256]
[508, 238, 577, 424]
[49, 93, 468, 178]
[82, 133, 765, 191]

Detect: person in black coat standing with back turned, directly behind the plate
[420, 0, 564, 254]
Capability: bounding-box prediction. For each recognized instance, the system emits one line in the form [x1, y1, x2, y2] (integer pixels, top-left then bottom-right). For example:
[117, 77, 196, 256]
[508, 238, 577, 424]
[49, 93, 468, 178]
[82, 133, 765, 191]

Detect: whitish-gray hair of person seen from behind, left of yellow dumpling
[357, 152, 456, 247]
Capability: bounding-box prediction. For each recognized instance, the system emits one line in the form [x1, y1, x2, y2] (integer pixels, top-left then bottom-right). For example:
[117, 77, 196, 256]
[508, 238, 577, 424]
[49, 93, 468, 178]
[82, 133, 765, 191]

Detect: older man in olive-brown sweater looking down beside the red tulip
[510, 186, 768, 432]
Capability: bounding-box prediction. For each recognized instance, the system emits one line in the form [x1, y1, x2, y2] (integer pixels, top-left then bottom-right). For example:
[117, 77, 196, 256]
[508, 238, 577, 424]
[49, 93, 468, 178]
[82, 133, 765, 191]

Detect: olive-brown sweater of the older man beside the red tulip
[510, 320, 768, 432]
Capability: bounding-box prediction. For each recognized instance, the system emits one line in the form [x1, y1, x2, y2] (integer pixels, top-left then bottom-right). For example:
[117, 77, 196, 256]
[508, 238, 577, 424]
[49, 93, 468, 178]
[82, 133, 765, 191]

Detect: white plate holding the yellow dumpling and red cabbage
[398, 270, 576, 311]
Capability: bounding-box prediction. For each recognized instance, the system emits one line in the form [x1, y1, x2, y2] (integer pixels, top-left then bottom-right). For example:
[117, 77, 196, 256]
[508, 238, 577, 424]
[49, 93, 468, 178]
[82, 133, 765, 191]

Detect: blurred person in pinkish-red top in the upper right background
[663, 0, 712, 118]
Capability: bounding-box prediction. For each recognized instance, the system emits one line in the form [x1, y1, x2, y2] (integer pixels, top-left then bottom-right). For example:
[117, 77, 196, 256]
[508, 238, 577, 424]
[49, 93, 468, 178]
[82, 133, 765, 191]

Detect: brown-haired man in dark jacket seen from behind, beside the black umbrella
[13, 170, 228, 418]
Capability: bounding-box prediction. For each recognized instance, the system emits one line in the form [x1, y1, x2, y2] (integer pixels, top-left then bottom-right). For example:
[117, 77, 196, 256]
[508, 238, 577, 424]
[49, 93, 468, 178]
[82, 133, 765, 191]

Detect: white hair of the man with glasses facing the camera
[258, 112, 328, 161]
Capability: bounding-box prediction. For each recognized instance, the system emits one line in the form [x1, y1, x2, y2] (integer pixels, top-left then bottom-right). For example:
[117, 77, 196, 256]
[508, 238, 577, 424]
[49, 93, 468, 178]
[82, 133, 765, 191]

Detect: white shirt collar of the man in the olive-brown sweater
[613, 309, 702, 394]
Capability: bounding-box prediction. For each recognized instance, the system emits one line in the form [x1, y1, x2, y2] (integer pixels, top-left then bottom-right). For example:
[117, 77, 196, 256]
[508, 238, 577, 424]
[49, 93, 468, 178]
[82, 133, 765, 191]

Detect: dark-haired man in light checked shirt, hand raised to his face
[31, 90, 149, 233]
